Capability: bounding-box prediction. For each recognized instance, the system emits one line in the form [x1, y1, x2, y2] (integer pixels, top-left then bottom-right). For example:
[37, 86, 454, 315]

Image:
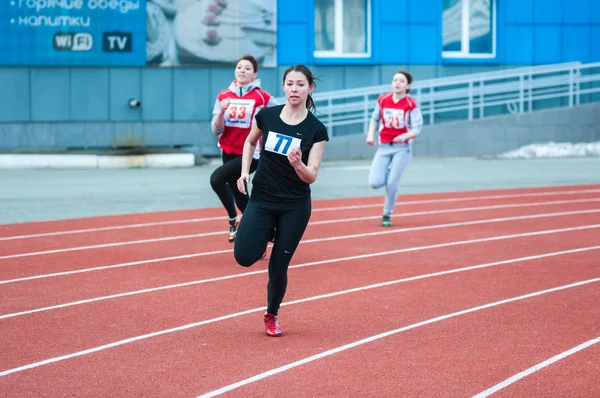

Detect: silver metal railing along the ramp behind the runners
[278, 62, 600, 136]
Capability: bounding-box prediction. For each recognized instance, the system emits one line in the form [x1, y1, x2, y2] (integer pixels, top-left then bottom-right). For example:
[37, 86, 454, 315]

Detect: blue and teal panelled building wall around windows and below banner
[0, 0, 600, 154]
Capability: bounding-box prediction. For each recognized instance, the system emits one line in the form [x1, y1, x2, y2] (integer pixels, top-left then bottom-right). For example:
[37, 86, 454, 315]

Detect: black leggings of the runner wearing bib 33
[210, 152, 258, 219]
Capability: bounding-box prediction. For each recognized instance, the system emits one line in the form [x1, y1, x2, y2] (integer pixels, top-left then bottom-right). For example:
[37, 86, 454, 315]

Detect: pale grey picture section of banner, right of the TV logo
[146, 0, 277, 67]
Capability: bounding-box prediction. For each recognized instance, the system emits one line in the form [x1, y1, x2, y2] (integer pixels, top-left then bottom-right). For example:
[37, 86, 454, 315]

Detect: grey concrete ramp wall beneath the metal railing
[324, 103, 600, 159]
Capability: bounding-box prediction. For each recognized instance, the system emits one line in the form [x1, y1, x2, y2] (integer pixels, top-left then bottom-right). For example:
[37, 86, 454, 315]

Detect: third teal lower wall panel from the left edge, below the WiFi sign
[70, 68, 109, 121]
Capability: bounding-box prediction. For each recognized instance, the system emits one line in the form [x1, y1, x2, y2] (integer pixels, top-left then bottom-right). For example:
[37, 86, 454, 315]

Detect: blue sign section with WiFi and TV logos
[0, 0, 146, 66]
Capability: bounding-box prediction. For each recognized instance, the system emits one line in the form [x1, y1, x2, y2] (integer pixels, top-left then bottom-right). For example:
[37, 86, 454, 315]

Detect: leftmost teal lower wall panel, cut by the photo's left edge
[0, 68, 31, 122]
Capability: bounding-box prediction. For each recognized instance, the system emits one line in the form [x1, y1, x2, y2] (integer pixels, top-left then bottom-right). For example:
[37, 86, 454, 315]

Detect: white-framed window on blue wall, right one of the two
[442, 0, 496, 58]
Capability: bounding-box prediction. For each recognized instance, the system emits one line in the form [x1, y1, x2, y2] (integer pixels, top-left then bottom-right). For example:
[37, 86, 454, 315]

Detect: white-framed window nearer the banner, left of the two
[315, 0, 371, 58]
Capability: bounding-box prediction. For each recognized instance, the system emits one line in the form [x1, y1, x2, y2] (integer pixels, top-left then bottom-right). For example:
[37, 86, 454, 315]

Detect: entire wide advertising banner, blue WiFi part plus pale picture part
[0, 0, 277, 67]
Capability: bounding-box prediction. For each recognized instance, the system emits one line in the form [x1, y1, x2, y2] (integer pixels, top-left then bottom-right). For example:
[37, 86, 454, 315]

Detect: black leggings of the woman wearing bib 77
[234, 197, 311, 315]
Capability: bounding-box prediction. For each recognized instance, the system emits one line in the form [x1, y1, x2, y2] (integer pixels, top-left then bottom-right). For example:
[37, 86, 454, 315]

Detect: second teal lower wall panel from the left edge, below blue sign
[31, 68, 71, 122]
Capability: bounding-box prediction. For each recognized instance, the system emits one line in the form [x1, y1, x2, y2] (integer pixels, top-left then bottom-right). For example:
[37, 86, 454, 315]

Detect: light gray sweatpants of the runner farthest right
[369, 143, 412, 216]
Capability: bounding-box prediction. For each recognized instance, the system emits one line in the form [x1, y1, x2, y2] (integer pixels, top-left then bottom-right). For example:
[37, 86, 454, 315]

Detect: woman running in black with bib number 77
[234, 65, 329, 336]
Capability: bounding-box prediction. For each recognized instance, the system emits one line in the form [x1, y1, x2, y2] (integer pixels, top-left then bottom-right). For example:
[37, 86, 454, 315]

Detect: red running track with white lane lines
[0, 186, 600, 397]
